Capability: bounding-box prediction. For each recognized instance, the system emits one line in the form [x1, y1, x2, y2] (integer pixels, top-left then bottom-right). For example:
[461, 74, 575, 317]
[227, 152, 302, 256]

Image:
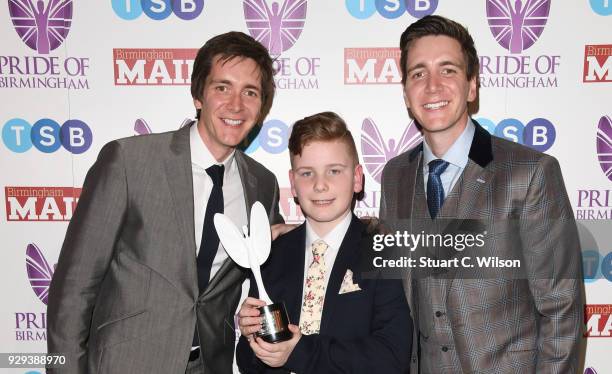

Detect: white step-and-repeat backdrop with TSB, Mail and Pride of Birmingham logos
[0, 0, 612, 374]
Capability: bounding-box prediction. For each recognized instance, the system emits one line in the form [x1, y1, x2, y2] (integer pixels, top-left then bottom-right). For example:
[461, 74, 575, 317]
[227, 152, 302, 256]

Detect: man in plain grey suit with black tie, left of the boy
[47, 32, 282, 374]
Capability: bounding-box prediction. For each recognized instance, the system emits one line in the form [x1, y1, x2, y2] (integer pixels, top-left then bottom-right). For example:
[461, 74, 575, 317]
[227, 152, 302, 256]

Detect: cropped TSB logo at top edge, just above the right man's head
[345, 0, 438, 19]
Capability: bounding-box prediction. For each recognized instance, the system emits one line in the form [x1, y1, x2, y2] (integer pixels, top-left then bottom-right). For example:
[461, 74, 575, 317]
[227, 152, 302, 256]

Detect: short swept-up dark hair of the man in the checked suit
[400, 15, 479, 85]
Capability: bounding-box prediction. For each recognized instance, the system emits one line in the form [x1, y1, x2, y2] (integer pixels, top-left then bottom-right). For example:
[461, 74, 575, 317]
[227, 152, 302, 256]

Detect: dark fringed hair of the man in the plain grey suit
[191, 31, 275, 125]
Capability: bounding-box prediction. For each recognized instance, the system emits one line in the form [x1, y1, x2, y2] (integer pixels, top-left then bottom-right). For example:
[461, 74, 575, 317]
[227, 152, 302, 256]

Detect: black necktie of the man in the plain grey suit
[197, 165, 225, 293]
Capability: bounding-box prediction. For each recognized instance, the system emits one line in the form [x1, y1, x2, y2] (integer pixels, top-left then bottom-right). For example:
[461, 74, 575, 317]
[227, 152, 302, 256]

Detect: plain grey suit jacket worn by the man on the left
[47, 126, 282, 374]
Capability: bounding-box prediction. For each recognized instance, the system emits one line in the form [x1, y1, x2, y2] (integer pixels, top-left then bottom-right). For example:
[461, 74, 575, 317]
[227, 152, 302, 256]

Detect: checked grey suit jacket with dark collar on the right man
[380, 124, 583, 373]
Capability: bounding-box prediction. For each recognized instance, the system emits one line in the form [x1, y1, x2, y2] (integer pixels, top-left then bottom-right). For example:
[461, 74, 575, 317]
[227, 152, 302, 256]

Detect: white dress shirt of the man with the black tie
[189, 124, 248, 280]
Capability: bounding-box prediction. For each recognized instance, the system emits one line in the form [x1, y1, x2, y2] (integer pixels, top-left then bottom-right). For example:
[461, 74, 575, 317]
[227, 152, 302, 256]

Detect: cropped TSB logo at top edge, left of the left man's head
[111, 0, 204, 21]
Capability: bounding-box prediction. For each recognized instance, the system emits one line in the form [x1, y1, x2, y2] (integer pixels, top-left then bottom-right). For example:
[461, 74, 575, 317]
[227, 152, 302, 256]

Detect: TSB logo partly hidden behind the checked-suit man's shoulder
[476, 118, 557, 152]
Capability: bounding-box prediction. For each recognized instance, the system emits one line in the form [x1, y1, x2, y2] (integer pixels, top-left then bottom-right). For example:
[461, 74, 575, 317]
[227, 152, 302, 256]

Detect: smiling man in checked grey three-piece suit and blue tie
[380, 16, 583, 373]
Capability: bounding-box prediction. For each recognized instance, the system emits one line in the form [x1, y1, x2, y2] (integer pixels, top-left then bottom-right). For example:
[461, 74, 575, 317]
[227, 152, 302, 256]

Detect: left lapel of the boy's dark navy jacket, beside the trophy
[284, 223, 306, 325]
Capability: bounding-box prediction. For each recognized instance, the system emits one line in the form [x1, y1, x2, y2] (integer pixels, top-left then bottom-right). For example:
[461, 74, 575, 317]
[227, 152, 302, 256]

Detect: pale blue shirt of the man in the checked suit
[423, 118, 476, 198]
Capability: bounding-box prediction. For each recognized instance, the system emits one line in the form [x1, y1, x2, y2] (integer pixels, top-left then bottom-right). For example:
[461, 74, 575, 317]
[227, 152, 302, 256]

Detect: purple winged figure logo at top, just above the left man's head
[243, 0, 307, 57]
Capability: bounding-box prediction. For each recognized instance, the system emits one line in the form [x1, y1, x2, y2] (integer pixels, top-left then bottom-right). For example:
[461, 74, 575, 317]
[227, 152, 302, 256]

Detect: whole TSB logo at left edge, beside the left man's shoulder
[2, 118, 93, 154]
